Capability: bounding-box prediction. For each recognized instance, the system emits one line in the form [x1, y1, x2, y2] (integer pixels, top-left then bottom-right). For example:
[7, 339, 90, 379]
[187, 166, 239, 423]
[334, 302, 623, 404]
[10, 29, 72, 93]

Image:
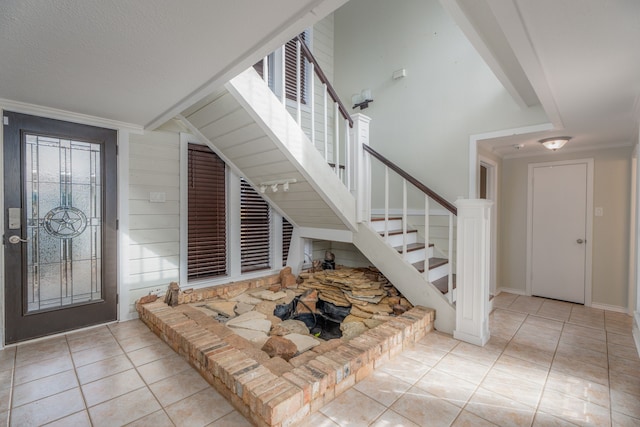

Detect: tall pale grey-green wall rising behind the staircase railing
[334, 0, 547, 207]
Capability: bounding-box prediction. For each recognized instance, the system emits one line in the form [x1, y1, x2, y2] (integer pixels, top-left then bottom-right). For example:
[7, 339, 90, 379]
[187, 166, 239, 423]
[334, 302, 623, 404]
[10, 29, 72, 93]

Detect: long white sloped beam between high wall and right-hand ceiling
[440, 0, 563, 128]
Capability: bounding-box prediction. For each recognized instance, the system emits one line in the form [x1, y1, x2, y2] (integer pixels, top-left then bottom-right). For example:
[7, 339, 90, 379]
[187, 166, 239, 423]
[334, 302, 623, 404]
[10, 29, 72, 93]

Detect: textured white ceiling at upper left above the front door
[0, 0, 346, 128]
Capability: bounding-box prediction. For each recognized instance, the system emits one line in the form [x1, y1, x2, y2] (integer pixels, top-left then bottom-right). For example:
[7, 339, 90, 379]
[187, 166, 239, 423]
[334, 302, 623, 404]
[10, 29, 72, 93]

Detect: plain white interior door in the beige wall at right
[530, 161, 591, 304]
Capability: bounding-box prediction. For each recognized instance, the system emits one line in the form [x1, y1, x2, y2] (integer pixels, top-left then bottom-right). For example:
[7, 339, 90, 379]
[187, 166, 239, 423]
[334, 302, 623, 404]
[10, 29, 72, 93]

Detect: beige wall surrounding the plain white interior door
[499, 147, 632, 311]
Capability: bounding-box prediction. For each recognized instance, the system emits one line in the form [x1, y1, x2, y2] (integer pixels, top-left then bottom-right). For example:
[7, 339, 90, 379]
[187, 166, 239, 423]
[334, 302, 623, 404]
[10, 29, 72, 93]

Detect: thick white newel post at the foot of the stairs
[453, 199, 493, 346]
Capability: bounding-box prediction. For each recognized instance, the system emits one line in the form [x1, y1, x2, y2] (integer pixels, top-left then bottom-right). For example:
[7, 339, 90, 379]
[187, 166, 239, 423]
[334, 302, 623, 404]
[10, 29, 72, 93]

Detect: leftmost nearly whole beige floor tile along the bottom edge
[11, 388, 85, 427]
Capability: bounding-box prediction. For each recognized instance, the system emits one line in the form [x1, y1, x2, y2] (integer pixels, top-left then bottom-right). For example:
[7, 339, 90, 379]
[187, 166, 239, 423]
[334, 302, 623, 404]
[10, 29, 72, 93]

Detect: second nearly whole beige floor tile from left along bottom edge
[89, 387, 160, 427]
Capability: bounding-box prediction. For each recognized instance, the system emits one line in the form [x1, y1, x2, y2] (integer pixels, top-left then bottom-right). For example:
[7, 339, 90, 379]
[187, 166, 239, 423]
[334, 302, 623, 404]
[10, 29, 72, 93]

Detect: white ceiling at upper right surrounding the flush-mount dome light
[441, 0, 640, 158]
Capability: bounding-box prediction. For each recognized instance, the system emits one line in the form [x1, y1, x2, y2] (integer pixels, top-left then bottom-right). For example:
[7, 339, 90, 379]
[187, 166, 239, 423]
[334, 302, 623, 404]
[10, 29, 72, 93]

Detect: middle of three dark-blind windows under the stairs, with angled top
[240, 179, 271, 273]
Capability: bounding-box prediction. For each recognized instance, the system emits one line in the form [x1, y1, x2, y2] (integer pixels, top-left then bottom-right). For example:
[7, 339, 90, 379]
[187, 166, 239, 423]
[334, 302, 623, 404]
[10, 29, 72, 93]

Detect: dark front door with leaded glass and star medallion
[3, 111, 117, 344]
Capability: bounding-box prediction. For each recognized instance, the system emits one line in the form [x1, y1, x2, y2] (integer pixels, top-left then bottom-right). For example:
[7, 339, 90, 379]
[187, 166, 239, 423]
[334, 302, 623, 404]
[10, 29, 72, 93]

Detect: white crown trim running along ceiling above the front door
[0, 98, 144, 134]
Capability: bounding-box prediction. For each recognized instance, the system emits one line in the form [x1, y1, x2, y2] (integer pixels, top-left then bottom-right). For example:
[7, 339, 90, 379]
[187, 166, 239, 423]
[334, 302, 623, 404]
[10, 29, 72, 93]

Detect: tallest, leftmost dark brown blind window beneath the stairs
[187, 144, 227, 280]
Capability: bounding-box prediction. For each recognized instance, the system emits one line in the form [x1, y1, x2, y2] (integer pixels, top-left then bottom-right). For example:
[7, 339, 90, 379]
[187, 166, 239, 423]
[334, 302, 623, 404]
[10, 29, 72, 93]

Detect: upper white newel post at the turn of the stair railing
[349, 113, 371, 222]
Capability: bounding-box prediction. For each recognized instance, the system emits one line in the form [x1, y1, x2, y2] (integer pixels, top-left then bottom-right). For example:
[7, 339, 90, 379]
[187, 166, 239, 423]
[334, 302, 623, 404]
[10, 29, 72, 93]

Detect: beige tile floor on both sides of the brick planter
[0, 293, 640, 427]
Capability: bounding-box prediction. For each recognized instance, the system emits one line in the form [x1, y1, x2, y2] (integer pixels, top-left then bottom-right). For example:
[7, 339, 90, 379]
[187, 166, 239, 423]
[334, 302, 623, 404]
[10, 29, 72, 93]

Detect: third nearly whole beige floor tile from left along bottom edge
[165, 388, 233, 427]
